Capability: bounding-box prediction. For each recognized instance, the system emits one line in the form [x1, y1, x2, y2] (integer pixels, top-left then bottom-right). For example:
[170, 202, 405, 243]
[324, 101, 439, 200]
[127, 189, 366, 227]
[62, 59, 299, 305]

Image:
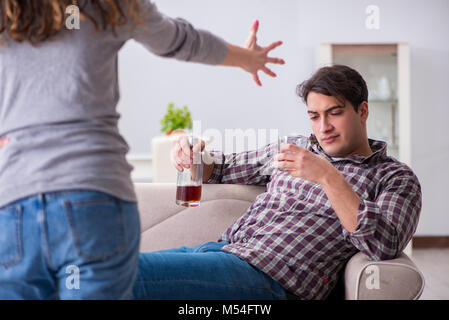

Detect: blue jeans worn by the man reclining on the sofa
[134, 242, 286, 300]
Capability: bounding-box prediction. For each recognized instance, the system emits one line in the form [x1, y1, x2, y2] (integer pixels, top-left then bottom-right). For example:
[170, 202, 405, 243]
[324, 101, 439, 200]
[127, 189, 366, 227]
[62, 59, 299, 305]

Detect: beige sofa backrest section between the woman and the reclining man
[135, 183, 265, 251]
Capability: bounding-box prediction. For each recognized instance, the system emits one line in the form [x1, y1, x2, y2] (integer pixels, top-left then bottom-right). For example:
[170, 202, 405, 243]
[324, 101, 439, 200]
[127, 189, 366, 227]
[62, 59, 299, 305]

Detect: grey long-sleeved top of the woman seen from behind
[0, 1, 226, 207]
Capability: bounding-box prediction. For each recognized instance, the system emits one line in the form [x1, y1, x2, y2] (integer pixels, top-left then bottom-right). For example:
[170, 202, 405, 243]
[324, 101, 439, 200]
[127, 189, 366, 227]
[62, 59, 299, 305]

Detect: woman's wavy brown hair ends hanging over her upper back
[0, 0, 144, 45]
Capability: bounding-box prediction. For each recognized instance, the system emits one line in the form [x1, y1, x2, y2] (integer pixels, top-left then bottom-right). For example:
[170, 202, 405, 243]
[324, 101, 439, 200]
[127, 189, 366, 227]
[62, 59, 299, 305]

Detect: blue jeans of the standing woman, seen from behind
[0, 190, 140, 299]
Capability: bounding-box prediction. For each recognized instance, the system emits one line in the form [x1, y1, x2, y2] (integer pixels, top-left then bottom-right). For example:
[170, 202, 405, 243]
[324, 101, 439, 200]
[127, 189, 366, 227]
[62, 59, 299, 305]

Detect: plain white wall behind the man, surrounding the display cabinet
[119, 0, 449, 235]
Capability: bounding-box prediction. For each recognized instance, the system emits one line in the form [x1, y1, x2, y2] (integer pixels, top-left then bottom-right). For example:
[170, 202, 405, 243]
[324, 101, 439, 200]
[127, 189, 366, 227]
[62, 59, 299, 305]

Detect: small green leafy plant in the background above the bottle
[161, 103, 192, 135]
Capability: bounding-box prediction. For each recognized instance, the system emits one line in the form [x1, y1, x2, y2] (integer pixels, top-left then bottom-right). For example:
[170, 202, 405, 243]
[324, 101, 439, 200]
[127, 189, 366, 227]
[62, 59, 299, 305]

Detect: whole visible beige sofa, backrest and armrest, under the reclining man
[135, 183, 424, 300]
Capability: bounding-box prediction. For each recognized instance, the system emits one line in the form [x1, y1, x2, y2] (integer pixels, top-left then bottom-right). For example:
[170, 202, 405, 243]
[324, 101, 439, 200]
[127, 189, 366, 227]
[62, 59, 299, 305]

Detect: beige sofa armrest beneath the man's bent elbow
[344, 252, 424, 300]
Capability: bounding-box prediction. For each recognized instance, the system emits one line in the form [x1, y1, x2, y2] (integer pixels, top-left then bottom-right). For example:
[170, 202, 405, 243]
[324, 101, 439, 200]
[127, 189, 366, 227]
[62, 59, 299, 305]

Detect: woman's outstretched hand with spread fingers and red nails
[221, 20, 285, 86]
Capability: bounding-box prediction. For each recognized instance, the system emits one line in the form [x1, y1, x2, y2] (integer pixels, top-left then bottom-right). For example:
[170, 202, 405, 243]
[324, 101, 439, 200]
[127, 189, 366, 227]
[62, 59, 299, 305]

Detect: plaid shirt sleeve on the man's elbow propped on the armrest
[343, 168, 422, 260]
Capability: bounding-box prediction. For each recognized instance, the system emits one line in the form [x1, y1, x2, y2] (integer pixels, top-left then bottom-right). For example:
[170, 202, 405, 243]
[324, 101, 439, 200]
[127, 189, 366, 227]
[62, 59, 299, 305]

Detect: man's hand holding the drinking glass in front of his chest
[275, 144, 336, 184]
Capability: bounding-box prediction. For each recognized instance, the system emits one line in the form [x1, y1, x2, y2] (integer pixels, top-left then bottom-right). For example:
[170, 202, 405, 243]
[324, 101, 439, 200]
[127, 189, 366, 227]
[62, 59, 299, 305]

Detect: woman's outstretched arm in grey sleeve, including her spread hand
[131, 1, 284, 86]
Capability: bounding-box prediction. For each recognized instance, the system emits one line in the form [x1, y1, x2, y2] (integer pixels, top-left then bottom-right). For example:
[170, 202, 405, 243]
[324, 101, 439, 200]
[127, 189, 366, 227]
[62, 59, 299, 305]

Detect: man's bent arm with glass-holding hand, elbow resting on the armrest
[276, 145, 422, 260]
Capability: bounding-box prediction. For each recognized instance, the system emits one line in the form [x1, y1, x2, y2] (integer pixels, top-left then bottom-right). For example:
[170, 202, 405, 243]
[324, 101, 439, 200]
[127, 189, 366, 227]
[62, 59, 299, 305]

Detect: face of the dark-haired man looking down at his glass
[307, 92, 368, 158]
